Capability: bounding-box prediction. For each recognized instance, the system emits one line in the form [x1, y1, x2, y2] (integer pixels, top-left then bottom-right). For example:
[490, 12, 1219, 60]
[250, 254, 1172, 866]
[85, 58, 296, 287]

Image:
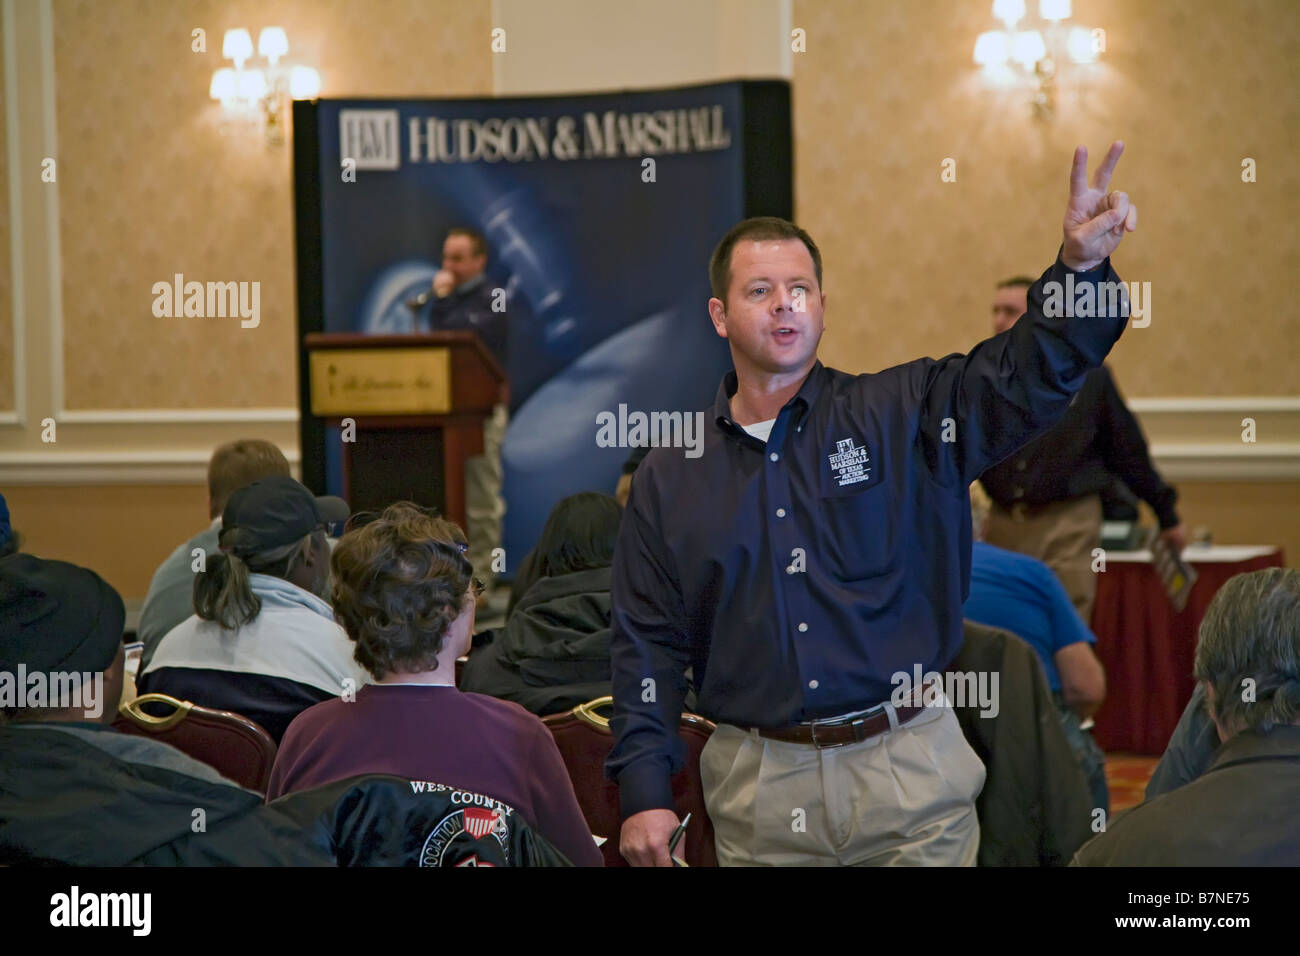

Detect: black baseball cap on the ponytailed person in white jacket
[218, 475, 351, 557]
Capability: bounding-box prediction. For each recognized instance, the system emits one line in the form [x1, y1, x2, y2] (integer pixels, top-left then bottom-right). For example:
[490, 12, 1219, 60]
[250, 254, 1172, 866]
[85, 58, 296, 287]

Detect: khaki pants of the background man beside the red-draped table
[984, 494, 1101, 627]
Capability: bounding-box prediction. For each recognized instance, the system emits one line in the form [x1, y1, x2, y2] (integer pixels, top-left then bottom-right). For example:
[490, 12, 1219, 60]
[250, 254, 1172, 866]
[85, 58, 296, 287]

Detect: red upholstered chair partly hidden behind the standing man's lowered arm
[542, 697, 718, 866]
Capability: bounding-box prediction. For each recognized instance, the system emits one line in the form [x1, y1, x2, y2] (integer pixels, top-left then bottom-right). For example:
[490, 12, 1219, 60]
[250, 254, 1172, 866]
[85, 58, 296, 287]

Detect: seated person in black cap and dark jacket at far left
[0, 554, 317, 865]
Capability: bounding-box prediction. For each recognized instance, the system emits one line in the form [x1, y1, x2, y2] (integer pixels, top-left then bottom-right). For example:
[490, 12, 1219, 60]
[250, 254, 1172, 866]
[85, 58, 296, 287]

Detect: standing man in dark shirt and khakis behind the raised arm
[980, 276, 1187, 626]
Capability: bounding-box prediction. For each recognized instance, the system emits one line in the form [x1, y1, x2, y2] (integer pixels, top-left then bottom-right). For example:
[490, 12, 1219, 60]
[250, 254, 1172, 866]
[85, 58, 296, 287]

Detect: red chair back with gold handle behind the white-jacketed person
[113, 693, 276, 793]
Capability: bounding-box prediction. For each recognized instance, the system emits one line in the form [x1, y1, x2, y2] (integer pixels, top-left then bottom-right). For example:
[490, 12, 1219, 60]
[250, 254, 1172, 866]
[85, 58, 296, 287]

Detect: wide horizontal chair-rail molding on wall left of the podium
[0, 449, 302, 486]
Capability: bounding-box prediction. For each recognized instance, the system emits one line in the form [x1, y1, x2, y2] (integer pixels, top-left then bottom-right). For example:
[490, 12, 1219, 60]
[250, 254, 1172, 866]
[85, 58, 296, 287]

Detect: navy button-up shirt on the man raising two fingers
[606, 252, 1126, 817]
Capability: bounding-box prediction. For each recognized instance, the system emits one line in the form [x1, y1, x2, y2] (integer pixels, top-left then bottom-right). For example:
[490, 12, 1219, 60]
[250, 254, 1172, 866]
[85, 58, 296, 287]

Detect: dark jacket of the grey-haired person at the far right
[1073, 726, 1300, 866]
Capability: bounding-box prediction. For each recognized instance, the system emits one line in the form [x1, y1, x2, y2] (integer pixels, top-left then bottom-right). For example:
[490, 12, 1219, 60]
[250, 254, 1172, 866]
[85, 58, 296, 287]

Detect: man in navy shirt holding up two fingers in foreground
[606, 142, 1138, 866]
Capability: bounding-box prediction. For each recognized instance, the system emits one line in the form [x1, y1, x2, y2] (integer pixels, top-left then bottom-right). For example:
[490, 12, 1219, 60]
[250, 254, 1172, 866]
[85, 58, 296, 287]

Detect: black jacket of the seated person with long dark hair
[458, 567, 610, 717]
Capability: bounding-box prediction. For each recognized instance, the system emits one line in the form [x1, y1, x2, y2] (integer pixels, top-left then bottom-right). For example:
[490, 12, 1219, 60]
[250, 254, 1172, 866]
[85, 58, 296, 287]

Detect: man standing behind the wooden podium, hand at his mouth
[420, 226, 510, 598]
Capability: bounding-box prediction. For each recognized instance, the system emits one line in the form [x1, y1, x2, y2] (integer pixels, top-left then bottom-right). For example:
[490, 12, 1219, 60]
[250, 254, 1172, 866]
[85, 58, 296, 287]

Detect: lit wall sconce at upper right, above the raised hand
[975, 0, 1106, 120]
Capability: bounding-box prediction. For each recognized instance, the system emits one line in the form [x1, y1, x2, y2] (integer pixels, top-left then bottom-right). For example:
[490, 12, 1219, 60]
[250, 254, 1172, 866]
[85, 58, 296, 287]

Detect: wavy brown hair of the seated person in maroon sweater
[330, 501, 473, 680]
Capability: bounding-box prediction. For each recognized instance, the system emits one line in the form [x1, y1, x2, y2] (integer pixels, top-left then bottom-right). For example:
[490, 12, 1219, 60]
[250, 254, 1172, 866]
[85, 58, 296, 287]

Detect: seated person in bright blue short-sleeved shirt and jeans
[962, 484, 1110, 812]
